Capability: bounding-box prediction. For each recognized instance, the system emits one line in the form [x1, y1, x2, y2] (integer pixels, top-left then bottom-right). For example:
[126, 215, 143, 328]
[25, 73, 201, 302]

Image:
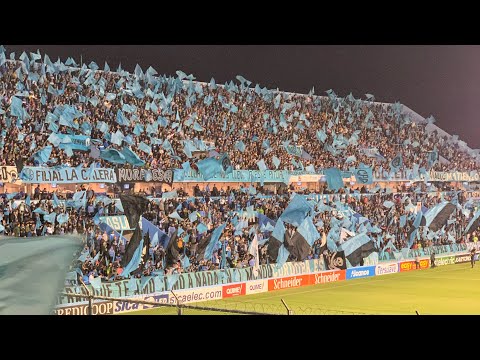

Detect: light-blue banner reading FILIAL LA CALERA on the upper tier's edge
[20, 166, 117, 184]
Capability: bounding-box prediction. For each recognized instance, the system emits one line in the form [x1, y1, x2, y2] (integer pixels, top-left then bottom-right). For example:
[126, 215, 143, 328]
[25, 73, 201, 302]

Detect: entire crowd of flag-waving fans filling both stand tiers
[0, 47, 478, 282]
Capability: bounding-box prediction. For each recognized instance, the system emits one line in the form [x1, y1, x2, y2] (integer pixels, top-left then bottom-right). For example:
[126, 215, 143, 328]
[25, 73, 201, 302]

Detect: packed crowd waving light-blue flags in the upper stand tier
[0, 47, 477, 176]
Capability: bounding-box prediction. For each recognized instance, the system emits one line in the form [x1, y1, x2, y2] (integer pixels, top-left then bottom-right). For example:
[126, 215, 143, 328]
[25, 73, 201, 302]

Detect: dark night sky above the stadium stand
[5, 45, 480, 148]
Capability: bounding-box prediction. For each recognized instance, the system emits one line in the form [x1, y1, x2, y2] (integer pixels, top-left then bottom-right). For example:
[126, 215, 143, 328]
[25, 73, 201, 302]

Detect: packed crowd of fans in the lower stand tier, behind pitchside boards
[0, 185, 478, 282]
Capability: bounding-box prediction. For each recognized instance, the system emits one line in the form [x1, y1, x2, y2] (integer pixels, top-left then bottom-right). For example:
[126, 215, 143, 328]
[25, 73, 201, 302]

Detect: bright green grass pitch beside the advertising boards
[124, 263, 480, 315]
